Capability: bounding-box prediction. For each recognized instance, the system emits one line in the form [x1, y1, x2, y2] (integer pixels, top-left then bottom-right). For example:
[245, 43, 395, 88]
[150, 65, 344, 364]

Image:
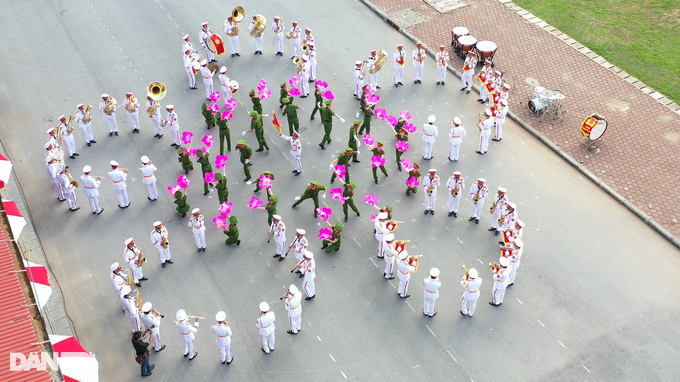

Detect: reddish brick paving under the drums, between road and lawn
[362, 0, 680, 245]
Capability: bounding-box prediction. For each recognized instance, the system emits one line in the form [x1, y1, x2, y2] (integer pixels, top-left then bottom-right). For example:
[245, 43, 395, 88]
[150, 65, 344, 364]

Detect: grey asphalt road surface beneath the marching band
[0, 0, 680, 381]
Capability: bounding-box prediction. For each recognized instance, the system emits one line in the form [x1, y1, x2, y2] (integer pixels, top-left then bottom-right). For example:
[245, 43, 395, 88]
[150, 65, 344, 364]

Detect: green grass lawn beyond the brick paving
[514, 0, 680, 104]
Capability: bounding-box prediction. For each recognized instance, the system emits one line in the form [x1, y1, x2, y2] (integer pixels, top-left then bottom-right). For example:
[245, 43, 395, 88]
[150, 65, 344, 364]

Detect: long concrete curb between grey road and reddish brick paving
[359, 0, 680, 249]
